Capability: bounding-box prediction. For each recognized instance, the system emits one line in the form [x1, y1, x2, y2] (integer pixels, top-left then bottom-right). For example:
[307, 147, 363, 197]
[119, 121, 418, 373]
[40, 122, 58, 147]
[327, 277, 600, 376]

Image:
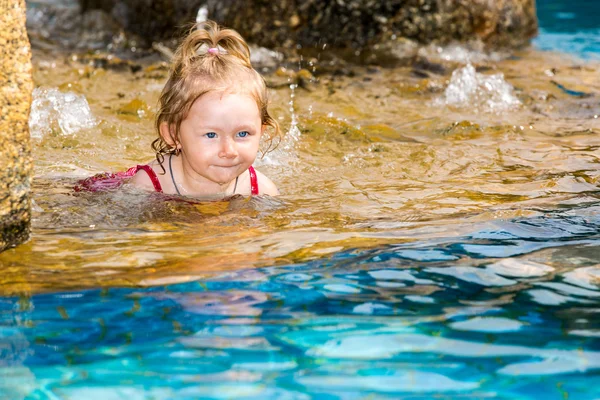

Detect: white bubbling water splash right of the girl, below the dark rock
[435, 64, 521, 112]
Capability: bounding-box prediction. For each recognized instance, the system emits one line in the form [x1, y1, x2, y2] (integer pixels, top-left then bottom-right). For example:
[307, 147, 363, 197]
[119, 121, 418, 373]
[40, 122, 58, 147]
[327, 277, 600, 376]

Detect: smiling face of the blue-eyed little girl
[170, 92, 263, 185]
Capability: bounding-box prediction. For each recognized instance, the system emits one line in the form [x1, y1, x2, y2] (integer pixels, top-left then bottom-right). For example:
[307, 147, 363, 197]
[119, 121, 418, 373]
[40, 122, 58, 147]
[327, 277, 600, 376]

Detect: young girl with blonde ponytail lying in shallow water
[76, 21, 281, 197]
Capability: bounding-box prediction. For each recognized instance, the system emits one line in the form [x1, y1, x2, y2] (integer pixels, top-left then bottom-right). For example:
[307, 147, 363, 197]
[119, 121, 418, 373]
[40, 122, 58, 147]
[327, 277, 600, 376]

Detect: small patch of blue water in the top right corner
[533, 0, 600, 60]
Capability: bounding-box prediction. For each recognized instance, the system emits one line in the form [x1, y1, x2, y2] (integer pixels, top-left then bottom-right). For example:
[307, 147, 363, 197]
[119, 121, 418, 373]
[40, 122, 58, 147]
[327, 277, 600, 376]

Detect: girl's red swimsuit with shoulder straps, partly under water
[75, 165, 258, 196]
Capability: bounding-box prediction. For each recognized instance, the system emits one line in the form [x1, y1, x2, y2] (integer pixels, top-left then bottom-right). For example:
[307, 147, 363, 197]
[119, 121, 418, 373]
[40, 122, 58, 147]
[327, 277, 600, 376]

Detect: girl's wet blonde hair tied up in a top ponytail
[152, 21, 281, 173]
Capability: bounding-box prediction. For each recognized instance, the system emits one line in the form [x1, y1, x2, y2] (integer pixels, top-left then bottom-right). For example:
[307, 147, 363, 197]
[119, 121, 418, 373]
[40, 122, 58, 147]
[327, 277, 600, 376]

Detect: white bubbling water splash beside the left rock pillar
[29, 88, 97, 139]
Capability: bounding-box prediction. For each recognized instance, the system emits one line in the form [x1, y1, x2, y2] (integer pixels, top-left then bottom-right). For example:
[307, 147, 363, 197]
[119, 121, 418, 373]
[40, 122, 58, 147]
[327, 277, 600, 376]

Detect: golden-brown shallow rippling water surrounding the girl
[0, 45, 600, 295]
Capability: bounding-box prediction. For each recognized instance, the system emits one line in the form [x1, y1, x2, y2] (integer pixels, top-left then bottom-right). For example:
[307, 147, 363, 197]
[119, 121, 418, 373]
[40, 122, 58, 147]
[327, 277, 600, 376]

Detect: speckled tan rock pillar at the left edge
[0, 0, 33, 251]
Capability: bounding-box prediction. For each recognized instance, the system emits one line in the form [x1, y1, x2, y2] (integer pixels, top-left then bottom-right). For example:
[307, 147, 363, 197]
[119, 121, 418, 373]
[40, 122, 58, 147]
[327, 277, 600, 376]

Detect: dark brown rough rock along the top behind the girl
[80, 0, 537, 50]
